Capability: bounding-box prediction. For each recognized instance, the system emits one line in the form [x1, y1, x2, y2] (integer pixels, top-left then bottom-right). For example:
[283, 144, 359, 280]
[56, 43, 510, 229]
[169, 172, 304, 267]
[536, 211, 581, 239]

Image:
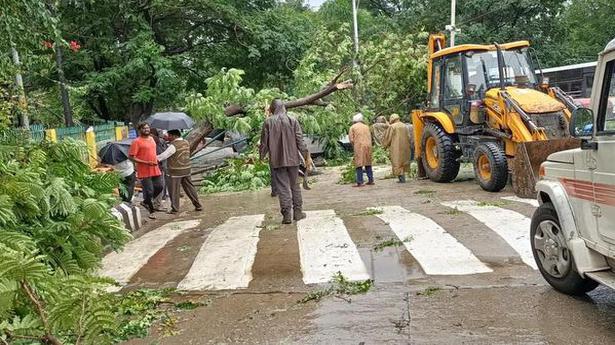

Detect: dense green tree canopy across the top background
[0, 0, 615, 128]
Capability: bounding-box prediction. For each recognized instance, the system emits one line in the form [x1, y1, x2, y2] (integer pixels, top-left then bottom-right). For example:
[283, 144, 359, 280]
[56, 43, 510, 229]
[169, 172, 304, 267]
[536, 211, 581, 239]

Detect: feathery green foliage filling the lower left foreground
[0, 135, 130, 344]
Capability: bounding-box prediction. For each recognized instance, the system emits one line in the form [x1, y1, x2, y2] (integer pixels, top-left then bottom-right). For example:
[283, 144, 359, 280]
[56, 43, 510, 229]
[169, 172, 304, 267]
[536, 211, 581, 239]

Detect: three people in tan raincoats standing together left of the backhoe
[348, 113, 412, 187]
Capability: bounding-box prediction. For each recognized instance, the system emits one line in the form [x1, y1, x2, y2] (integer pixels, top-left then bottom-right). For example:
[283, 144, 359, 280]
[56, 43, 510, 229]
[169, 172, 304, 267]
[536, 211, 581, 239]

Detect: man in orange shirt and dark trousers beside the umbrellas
[128, 122, 162, 218]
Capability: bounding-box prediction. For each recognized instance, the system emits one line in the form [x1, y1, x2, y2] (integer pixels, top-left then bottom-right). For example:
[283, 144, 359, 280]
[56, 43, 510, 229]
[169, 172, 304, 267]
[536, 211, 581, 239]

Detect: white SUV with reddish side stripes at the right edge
[531, 39, 615, 295]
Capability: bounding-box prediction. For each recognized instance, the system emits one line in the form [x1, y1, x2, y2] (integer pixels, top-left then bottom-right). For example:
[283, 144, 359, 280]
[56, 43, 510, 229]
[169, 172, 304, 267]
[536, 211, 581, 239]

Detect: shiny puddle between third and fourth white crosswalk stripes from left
[359, 246, 425, 283]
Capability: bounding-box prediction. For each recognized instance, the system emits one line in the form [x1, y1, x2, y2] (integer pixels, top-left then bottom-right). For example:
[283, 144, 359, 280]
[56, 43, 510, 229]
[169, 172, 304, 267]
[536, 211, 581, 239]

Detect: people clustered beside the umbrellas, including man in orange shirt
[114, 123, 203, 218]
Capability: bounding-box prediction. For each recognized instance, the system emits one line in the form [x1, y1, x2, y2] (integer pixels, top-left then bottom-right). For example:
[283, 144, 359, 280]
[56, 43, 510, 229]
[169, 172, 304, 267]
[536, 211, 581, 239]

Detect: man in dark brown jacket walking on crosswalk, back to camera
[259, 99, 307, 224]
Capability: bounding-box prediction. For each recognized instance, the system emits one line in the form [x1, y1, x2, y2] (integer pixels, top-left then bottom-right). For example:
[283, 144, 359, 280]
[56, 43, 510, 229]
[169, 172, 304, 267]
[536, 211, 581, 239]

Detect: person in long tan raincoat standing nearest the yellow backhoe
[382, 114, 410, 183]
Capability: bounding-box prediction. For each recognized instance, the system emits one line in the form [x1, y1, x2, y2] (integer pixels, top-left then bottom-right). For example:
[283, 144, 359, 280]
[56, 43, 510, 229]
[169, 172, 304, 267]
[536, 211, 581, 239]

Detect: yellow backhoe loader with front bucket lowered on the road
[412, 34, 579, 197]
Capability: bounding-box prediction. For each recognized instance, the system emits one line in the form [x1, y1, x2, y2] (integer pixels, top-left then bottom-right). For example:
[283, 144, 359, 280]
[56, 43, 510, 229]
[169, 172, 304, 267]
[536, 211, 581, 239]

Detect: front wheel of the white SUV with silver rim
[530, 203, 598, 295]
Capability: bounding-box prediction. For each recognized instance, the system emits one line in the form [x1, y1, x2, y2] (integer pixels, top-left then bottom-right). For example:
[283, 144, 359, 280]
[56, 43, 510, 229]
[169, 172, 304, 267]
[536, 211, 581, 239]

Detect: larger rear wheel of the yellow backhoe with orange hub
[421, 123, 460, 182]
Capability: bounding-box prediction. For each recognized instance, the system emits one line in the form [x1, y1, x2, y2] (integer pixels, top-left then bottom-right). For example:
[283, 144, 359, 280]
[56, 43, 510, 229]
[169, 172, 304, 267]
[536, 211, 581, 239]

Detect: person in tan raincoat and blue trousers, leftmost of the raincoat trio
[348, 113, 374, 187]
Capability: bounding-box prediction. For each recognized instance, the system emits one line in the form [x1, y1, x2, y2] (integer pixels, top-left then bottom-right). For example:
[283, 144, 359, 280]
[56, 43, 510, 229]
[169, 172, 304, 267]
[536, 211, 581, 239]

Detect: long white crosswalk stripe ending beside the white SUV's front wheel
[442, 200, 538, 269]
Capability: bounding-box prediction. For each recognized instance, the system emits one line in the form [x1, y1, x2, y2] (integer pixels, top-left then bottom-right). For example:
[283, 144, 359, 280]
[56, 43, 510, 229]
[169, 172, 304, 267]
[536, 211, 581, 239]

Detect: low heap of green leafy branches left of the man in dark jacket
[201, 154, 271, 193]
